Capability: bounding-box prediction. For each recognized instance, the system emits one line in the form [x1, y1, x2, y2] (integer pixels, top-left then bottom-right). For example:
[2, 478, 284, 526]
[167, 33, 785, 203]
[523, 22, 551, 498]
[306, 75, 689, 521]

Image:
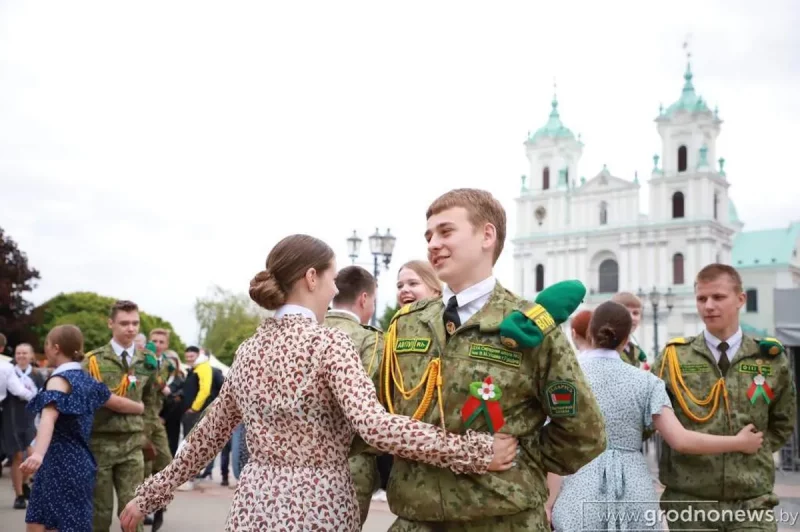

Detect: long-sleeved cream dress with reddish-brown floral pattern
[136, 314, 493, 531]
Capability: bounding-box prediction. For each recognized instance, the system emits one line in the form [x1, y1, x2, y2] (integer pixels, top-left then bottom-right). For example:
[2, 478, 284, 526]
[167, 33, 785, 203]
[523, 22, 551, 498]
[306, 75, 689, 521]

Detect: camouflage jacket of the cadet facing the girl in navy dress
[82, 343, 156, 435]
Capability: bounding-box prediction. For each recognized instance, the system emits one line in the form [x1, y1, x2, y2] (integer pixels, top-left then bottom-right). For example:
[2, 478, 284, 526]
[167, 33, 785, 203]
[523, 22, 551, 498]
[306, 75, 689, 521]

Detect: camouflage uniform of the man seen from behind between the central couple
[323, 309, 383, 526]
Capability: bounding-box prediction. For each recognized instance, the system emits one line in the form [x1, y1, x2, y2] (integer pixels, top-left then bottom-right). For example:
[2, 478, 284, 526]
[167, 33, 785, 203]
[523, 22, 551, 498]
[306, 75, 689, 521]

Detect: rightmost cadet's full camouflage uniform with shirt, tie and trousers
[653, 330, 797, 532]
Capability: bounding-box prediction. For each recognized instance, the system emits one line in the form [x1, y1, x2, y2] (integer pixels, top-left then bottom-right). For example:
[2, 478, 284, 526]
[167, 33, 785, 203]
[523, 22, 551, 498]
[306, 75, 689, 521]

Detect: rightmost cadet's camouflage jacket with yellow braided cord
[652, 334, 796, 501]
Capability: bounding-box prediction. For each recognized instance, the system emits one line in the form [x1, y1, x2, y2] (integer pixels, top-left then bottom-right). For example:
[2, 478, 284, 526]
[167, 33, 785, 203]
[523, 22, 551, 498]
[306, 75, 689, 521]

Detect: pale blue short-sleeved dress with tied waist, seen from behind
[553, 349, 672, 532]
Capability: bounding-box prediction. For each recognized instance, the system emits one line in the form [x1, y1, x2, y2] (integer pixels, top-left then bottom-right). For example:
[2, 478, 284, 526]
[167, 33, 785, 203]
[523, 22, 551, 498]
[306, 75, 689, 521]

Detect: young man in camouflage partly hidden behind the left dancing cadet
[144, 329, 174, 532]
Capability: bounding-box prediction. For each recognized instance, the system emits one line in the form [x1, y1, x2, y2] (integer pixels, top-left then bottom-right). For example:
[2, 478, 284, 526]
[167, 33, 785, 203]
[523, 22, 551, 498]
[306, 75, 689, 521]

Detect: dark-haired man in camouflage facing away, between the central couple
[324, 266, 383, 526]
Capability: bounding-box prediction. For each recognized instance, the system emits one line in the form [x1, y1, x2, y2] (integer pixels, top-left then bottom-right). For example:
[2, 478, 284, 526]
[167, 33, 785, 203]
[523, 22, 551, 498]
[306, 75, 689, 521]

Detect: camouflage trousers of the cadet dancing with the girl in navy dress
[89, 432, 144, 532]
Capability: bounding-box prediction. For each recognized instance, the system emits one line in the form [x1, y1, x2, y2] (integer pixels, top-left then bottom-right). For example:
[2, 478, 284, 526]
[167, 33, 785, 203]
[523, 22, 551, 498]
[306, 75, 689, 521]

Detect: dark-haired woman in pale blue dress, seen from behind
[547, 301, 764, 532]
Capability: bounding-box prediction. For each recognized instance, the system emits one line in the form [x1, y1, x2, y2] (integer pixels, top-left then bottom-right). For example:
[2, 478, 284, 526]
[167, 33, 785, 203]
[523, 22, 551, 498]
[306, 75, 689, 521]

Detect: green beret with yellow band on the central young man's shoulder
[500, 280, 586, 349]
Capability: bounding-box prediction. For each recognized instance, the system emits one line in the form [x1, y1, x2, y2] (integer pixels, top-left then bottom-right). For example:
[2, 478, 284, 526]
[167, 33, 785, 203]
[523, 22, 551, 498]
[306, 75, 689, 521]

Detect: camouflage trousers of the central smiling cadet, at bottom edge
[389, 508, 552, 532]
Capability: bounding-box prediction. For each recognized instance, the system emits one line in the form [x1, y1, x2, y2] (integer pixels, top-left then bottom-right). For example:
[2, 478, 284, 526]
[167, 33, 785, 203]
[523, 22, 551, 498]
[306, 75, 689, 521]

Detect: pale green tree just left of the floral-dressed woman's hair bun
[194, 286, 270, 365]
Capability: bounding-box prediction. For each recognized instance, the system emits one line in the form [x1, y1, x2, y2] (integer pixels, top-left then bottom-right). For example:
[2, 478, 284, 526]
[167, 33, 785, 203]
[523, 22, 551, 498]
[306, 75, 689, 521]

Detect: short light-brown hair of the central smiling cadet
[426, 188, 506, 264]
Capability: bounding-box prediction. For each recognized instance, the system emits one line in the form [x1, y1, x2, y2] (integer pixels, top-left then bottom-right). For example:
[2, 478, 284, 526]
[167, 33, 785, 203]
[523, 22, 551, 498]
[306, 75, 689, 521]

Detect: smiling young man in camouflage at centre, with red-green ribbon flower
[381, 189, 606, 532]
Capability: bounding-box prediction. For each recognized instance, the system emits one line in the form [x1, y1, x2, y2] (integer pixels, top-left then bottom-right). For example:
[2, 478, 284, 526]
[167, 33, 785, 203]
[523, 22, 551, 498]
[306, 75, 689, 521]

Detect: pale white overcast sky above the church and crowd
[0, 0, 800, 341]
